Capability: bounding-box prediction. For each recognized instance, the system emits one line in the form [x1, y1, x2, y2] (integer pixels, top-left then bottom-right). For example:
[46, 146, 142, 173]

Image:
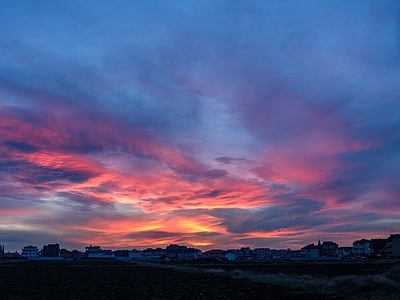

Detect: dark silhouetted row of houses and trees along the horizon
[0, 234, 400, 261]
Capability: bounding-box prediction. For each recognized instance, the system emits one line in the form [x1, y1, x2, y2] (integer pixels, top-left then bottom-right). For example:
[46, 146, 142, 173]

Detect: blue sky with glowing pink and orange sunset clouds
[0, 0, 400, 251]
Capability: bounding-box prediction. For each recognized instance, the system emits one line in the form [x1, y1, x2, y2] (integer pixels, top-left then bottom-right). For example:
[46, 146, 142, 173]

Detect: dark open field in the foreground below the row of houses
[0, 261, 400, 300]
